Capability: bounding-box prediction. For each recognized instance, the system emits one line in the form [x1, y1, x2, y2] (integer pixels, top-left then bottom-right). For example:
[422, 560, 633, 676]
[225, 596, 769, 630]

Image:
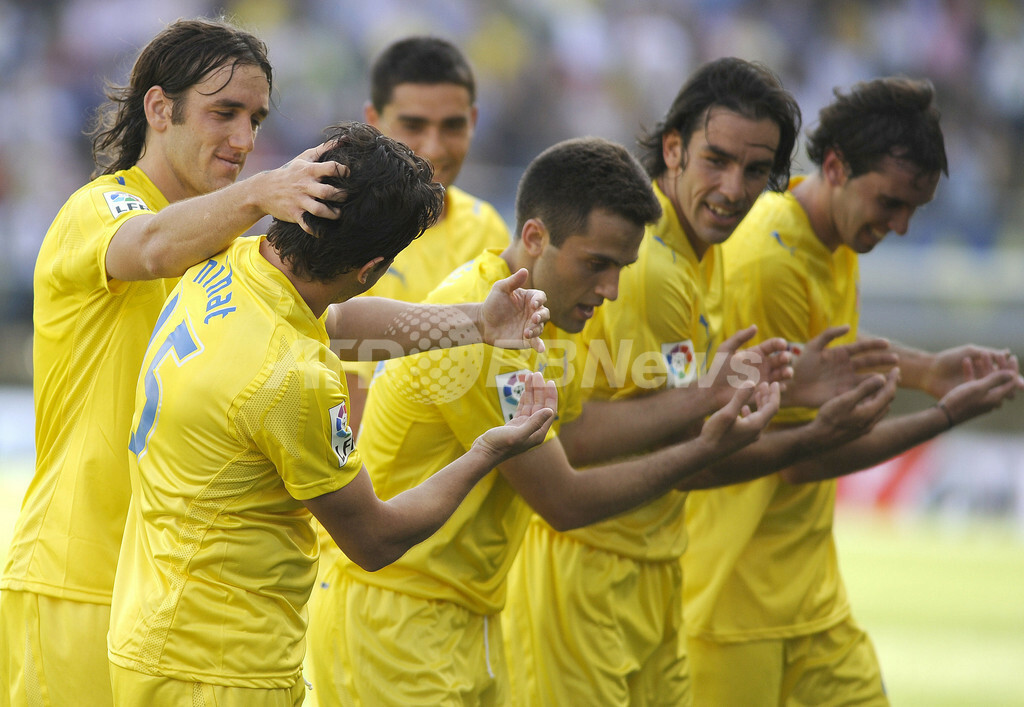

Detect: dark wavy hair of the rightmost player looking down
[807, 77, 949, 176]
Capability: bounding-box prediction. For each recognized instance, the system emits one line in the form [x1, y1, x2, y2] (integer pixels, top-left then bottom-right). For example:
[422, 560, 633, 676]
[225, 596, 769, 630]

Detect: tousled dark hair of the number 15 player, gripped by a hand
[267, 122, 444, 282]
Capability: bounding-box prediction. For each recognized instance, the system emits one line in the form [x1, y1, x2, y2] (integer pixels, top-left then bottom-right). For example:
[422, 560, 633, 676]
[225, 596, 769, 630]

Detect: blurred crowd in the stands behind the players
[0, 0, 1024, 397]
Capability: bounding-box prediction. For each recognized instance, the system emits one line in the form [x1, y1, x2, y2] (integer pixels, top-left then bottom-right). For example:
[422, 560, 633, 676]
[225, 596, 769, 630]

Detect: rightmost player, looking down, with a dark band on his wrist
[683, 78, 1022, 706]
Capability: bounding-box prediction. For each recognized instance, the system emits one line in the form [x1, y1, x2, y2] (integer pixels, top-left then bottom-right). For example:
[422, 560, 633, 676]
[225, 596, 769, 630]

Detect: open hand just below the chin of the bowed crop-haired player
[477, 267, 551, 351]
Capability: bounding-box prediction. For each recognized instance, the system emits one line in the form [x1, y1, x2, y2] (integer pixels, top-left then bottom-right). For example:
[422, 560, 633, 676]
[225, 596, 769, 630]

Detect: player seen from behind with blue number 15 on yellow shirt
[110, 123, 555, 707]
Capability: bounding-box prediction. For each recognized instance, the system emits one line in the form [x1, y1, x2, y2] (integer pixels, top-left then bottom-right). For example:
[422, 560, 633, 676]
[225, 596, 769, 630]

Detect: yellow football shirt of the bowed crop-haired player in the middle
[338, 249, 583, 614]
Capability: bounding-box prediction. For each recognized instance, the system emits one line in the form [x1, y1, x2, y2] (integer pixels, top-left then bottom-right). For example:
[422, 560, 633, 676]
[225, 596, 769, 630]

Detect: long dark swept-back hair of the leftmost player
[87, 18, 273, 177]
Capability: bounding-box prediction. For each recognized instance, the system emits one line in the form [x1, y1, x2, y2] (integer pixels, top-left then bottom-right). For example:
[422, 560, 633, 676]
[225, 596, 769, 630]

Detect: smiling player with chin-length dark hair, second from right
[503, 57, 894, 705]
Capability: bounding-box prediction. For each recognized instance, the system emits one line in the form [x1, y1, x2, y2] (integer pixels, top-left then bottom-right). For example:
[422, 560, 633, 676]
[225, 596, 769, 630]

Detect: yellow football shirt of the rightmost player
[683, 179, 858, 641]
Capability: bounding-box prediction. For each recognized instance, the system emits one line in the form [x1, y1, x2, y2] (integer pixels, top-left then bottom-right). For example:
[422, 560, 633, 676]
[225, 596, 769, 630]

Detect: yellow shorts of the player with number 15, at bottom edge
[108, 663, 306, 707]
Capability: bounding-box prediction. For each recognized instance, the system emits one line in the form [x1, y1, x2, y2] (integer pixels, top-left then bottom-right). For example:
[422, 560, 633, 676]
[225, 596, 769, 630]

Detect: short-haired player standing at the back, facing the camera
[345, 36, 509, 424]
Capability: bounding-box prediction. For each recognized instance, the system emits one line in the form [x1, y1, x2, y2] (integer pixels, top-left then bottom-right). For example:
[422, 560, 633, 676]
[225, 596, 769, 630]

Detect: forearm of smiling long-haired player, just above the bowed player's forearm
[560, 385, 725, 466]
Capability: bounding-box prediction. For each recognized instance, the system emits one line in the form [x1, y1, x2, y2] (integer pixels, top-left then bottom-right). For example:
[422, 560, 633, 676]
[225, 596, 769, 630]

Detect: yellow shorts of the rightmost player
[688, 619, 889, 707]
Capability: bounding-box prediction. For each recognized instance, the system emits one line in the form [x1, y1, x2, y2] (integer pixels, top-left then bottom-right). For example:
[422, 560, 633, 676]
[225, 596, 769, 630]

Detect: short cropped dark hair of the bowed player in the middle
[515, 137, 662, 246]
